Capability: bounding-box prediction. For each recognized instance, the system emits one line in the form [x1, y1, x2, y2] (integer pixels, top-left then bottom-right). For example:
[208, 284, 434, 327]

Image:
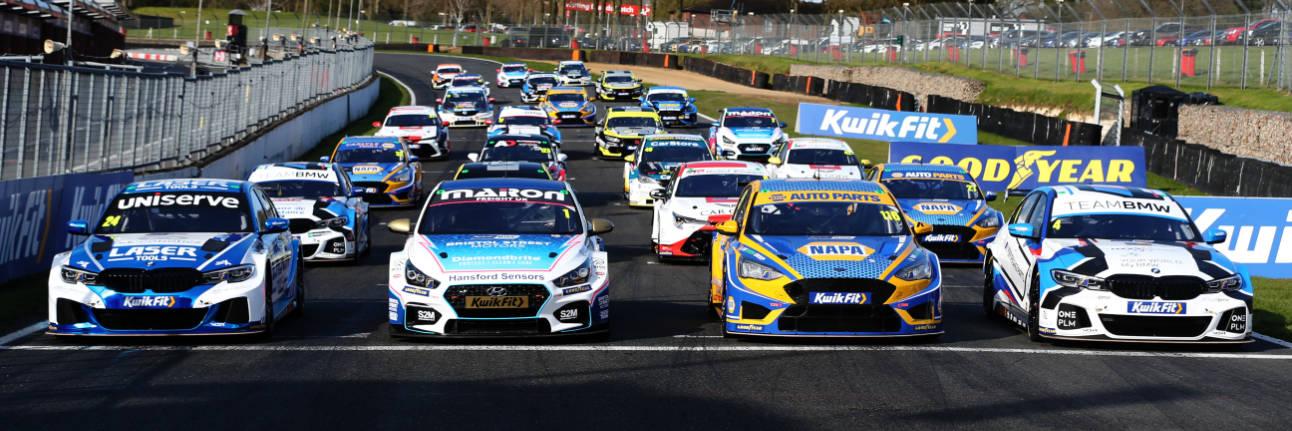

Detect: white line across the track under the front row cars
[0, 343, 1292, 360]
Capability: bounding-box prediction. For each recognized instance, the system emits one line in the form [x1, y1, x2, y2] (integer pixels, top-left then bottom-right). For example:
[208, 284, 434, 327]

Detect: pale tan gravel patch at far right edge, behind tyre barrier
[1178, 105, 1292, 165]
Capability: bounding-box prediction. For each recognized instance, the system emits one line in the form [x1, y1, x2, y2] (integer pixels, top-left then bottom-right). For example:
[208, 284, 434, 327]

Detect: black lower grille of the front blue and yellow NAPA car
[776, 279, 902, 332]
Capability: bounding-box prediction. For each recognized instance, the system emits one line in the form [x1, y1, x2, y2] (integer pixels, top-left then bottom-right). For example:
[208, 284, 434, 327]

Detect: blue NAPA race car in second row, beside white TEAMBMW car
[873, 162, 1005, 263]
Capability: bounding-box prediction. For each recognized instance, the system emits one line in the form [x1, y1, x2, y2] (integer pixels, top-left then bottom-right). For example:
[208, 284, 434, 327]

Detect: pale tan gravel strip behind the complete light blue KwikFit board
[789, 65, 987, 106]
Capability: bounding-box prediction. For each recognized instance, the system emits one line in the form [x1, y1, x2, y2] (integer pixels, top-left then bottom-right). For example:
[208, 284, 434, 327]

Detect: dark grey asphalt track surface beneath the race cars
[0, 54, 1292, 430]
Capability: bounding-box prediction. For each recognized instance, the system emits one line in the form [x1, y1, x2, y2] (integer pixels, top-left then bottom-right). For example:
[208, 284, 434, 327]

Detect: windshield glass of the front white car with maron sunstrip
[417, 201, 583, 235]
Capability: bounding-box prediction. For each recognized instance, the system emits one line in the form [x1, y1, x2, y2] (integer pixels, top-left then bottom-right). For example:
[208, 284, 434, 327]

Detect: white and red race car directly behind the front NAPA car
[651, 161, 767, 262]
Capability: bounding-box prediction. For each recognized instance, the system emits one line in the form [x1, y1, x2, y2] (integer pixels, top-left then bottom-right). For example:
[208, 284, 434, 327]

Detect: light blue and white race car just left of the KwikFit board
[709, 107, 788, 160]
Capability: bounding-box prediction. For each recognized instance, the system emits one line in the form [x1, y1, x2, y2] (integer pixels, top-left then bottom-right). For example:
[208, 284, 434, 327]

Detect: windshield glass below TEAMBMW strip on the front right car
[1047, 214, 1202, 241]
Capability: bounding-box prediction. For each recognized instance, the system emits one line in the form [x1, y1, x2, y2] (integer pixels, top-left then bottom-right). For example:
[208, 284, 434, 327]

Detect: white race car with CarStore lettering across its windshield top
[624, 134, 713, 206]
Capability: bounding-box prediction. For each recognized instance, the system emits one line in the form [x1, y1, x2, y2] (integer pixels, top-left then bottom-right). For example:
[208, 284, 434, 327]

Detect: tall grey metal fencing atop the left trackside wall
[0, 40, 373, 181]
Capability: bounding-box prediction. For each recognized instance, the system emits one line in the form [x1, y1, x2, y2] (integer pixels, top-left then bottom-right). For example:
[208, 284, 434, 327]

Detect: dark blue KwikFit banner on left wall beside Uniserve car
[0, 172, 134, 283]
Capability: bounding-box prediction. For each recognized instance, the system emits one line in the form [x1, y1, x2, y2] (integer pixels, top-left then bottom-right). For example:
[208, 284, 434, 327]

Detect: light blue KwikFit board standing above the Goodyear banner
[795, 103, 978, 145]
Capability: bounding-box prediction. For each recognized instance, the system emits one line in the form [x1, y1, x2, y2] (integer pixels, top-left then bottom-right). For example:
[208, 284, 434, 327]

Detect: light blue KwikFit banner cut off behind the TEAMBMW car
[1176, 196, 1292, 279]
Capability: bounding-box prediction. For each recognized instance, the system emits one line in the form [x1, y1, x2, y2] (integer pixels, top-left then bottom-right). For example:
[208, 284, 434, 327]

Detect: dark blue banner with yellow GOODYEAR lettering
[889, 142, 1149, 192]
